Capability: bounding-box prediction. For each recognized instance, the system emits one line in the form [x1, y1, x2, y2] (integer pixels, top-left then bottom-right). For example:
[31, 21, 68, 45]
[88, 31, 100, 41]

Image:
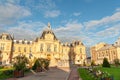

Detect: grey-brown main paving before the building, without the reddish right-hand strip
[7, 68, 69, 80]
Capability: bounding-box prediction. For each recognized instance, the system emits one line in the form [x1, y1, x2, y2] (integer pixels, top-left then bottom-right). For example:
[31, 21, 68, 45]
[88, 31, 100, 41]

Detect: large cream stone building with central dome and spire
[0, 23, 86, 67]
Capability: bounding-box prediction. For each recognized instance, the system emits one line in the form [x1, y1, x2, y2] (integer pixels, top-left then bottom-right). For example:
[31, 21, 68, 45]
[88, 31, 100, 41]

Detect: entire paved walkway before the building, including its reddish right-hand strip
[7, 68, 81, 80]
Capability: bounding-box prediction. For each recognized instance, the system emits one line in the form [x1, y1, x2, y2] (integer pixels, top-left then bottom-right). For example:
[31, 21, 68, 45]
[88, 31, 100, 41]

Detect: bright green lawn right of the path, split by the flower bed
[78, 67, 120, 80]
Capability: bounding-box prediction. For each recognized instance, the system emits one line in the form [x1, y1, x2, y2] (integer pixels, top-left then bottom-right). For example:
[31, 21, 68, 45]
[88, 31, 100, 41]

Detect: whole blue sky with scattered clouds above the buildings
[0, 0, 120, 46]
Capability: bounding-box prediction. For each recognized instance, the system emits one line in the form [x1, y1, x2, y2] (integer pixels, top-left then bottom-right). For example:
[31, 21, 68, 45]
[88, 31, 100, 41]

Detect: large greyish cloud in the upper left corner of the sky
[0, 3, 31, 26]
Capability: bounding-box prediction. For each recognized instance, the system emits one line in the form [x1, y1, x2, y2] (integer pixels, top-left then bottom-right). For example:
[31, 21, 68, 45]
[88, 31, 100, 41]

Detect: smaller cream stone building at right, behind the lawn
[90, 42, 120, 64]
